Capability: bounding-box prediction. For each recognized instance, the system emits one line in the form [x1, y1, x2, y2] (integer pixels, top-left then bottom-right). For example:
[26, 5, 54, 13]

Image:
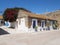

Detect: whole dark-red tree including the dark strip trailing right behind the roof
[3, 7, 31, 22]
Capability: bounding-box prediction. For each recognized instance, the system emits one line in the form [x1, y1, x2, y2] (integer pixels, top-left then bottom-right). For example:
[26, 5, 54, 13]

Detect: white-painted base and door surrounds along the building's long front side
[29, 19, 54, 31]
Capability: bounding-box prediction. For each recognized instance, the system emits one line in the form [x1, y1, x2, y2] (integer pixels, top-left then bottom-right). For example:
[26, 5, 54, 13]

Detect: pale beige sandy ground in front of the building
[0, 30, 60, 45]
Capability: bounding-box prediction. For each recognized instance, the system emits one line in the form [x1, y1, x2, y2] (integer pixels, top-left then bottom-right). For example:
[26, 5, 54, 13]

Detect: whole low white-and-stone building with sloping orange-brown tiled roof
[2, 7, 57, 32]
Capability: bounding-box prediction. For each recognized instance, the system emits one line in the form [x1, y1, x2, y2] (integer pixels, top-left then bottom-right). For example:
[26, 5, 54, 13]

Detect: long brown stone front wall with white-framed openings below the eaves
[28, 18, 55, 31]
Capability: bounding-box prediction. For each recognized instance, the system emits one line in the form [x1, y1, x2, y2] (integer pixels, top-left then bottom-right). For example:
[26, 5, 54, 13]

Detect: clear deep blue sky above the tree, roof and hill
[0, 0, 60, 15]
